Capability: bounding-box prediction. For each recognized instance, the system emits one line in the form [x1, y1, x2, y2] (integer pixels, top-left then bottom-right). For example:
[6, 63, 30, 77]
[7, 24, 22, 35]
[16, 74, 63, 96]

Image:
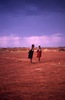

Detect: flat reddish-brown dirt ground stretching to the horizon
[0, 49, 65, 100]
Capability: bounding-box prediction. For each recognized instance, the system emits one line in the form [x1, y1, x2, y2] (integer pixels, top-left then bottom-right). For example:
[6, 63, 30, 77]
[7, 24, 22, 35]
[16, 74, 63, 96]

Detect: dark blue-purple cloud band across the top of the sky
[0, 0, 65, 14]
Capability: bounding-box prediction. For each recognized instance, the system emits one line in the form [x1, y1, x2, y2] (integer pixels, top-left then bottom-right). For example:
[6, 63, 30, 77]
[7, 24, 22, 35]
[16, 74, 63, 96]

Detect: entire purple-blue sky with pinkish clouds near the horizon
[0, 0, 65, 47]
